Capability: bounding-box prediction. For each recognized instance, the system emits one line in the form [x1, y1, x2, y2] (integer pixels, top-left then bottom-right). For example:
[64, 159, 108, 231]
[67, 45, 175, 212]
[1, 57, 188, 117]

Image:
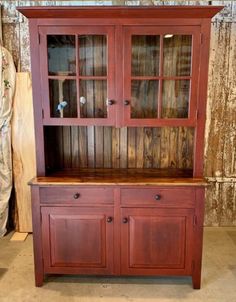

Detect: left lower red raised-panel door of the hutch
[41, 207, 113, 274]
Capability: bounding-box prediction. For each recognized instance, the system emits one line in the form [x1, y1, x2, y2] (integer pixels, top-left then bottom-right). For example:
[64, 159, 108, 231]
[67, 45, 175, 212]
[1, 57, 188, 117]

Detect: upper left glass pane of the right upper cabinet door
[131, 35, 160, 76]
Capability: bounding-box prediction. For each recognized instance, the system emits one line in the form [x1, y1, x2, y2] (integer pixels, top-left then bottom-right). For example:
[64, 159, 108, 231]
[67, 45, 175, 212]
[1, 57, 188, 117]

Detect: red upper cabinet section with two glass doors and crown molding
[19, 6, 222, 127]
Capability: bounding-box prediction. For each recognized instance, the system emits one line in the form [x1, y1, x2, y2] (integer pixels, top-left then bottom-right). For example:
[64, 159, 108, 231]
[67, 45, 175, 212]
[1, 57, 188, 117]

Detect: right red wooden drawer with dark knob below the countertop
[121, 187, 195, 208]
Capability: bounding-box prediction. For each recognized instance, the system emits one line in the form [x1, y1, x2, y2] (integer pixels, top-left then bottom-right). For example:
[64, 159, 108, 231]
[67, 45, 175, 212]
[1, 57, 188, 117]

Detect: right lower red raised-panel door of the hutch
[121, 208, 193, 275]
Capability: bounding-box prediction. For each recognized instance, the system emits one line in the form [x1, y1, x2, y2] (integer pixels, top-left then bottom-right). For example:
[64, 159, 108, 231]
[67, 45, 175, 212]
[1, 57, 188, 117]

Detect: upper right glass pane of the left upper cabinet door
[79, 35, 107, 76]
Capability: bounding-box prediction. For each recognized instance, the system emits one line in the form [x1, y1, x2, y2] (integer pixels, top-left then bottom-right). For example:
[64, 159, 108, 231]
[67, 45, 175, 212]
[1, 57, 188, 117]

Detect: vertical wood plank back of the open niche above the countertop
[45, 126, 194, 172]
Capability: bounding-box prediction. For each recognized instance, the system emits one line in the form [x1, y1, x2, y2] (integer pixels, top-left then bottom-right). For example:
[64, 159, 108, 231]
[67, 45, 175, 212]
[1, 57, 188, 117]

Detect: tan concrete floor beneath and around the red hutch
[0, 228, 236, 302]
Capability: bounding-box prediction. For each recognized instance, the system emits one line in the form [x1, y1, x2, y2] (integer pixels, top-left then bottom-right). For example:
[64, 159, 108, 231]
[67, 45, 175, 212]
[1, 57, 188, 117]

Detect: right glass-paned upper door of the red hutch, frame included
[124, 26, 200, 126]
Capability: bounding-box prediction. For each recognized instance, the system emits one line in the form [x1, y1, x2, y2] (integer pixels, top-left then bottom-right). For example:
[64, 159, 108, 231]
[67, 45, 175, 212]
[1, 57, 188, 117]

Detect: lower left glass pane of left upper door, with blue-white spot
[49, 80, 77, 117]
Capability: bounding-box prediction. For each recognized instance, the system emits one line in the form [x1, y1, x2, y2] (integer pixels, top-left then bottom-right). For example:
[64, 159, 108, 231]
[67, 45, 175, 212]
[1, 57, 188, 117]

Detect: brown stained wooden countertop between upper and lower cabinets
[29, 169, 207, 186]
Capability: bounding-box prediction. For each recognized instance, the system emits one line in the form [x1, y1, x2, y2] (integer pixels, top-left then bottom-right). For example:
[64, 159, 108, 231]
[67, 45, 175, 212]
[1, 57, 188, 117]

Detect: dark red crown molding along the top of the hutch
[17, 5, 224, 19]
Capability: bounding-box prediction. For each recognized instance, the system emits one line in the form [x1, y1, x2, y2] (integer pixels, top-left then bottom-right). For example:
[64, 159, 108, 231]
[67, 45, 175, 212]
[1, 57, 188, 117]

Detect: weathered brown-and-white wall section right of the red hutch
[204, 18, 236, 226]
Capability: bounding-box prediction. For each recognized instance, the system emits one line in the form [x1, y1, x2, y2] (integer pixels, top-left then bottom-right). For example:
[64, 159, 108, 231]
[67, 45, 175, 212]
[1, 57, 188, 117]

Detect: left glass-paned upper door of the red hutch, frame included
[40, 27, 115, 125]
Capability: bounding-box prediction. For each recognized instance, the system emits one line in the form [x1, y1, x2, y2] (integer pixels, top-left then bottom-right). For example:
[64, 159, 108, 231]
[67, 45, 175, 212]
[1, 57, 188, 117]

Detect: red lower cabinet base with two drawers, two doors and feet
[32, 186, 204, 288]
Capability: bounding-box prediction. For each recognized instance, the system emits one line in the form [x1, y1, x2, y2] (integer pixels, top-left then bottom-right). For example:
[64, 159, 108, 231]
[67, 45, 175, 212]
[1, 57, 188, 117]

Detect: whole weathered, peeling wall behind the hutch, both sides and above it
[0, 0, 236, 226]
